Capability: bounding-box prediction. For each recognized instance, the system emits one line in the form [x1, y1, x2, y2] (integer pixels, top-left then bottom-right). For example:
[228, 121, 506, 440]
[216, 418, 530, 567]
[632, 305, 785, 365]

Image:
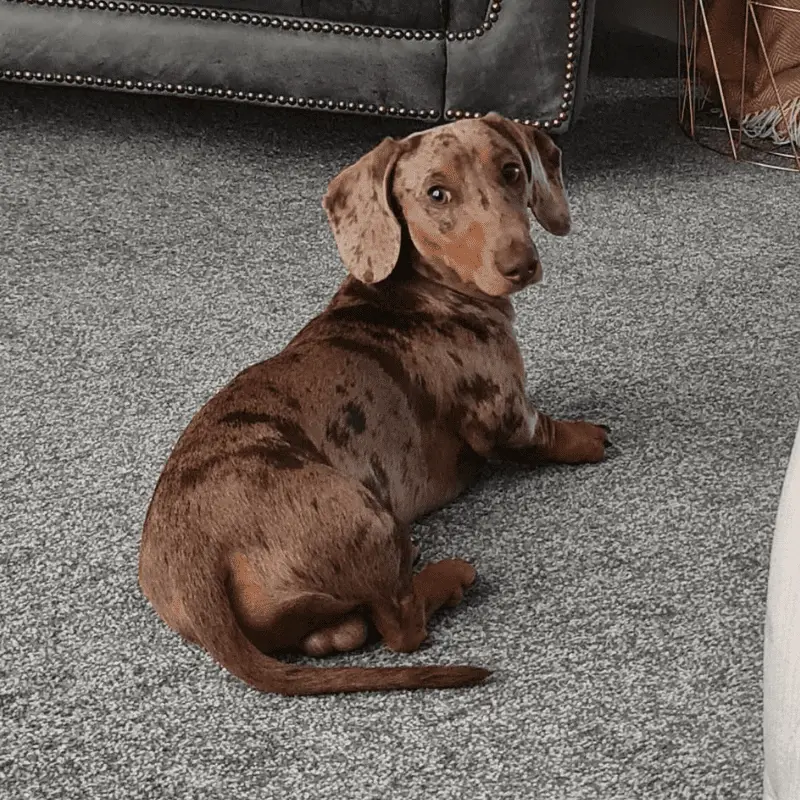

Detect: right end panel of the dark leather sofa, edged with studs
[445, 0, 594, 132]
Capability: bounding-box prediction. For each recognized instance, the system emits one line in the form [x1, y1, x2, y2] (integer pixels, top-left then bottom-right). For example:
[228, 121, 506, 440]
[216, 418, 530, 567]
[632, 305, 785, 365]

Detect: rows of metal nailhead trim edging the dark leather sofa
[0, 0, 581, 129]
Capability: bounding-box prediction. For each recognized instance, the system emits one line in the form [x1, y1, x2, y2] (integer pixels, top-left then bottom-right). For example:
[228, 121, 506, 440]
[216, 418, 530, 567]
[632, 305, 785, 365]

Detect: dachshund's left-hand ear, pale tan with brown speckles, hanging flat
[322, 137, 401, 283]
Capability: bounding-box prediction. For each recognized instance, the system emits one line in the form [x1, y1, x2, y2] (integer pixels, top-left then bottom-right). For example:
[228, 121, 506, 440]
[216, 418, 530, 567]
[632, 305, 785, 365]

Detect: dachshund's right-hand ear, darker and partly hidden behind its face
[483, 111, 572, 236]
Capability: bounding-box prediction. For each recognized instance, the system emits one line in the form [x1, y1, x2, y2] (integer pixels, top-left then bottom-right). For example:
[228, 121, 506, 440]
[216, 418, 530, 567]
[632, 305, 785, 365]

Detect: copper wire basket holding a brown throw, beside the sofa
[678, 0, 800, 172]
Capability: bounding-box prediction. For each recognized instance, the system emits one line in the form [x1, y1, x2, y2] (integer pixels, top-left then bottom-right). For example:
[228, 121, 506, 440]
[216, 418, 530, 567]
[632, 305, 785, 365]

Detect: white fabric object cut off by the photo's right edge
[764, 418, 800, 800]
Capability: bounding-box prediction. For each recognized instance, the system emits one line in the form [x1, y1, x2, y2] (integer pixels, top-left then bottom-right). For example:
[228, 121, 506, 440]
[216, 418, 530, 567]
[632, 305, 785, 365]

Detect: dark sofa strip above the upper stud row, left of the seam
[173, 0, 447, 30]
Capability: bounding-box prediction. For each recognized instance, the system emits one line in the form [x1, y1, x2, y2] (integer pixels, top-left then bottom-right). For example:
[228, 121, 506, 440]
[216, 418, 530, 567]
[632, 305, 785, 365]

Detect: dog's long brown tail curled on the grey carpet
[184, 564, 491, 696]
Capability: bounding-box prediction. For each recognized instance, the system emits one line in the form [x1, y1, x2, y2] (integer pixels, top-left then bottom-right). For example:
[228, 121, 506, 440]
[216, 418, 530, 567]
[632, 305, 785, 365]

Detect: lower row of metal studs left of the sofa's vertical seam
[0, 69, 440, 120]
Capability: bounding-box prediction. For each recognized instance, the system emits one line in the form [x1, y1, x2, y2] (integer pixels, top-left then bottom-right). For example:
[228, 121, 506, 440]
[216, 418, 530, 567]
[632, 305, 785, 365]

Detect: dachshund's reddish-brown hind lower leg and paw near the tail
[372, 558, 475, 653]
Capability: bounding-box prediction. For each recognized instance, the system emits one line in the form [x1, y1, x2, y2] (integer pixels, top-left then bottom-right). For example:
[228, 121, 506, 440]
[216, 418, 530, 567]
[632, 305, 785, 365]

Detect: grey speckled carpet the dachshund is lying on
[0, 28, 800, 800]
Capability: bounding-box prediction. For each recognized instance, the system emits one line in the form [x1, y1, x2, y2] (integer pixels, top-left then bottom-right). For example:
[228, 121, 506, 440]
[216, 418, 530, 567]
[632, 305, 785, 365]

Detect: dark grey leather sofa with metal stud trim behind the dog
[0, 0, 594, 132]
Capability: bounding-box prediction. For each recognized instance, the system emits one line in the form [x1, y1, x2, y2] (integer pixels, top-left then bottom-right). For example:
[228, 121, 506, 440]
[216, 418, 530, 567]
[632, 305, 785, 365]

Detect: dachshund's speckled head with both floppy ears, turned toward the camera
[323, 113, 570, 297]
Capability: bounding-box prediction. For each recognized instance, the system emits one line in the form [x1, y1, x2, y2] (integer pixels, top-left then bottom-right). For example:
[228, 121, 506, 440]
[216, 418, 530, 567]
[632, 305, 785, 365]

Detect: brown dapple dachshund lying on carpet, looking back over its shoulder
[139, 114, 607, 695]
